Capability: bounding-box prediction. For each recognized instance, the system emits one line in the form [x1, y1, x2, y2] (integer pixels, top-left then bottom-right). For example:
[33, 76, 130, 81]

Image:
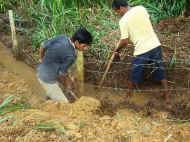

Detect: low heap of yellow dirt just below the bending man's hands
[40, 97, 101, 119]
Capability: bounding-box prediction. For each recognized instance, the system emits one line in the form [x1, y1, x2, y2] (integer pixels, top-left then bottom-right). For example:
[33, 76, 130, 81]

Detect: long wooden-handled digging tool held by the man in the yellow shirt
[98, 46, 119, 88]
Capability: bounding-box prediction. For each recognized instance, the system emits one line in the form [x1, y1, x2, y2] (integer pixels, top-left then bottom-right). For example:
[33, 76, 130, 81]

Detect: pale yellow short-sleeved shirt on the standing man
[119, 6, 161, 56]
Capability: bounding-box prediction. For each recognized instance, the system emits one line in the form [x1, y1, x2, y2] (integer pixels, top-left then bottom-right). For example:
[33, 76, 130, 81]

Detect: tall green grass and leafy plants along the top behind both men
[0, 0, 187, 58]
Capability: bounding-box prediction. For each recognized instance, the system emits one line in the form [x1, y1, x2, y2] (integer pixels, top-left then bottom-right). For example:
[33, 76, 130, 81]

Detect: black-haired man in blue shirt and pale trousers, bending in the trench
[37, 28, 92, 103]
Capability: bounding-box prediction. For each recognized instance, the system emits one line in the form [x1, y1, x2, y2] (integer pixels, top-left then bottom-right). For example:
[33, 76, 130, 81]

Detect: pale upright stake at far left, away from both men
[8, 10, 19, 58]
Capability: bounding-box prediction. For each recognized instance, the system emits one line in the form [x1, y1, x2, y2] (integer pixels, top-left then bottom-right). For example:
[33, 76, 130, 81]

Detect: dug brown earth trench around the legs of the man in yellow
[85, 44, 190, 120]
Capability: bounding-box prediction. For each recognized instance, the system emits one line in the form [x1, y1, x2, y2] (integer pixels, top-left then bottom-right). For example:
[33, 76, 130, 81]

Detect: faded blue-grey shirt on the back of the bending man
[38, 35, 76, 83]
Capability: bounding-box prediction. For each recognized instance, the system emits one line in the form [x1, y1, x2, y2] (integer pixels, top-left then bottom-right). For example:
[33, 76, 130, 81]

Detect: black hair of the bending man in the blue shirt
[72, 27, 92, 45]
